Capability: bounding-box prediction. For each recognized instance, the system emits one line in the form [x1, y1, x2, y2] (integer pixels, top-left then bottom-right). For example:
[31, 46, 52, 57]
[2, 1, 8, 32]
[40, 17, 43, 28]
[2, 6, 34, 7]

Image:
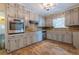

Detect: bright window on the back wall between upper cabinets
[53, 17, 66, 28]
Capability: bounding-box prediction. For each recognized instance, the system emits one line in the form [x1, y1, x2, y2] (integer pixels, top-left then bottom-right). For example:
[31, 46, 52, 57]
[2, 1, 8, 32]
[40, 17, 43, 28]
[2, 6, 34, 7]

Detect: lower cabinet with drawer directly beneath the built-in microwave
[6, 35, 24, 52]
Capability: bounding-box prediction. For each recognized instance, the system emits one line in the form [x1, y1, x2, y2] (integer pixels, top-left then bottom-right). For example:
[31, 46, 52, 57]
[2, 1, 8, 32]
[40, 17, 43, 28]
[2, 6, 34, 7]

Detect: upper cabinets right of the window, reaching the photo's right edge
[65, 8, 79, 26]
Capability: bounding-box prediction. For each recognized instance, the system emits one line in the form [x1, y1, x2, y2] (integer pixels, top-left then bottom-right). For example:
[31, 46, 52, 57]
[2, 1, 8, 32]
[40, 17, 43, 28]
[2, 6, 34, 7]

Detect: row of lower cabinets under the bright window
[47, 31, 72, 43]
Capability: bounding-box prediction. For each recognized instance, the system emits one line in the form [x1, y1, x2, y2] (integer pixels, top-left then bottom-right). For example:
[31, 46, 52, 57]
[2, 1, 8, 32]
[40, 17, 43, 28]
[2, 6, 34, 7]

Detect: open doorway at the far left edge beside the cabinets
[0, 11, 6, 50]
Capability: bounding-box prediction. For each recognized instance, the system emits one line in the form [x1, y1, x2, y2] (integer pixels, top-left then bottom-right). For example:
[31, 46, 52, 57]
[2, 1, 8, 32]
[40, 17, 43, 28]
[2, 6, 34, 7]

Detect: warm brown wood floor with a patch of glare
[10, 40, 79, 55]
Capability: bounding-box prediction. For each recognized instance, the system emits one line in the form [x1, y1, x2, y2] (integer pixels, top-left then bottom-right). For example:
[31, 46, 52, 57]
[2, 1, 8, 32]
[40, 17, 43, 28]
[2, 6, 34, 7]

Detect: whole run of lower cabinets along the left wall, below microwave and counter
[6, 31, 42, 52]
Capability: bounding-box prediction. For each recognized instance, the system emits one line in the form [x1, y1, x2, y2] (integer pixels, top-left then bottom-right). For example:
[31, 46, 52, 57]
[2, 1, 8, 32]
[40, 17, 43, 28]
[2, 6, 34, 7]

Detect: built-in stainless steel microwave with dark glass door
[9, 19, 24, 34]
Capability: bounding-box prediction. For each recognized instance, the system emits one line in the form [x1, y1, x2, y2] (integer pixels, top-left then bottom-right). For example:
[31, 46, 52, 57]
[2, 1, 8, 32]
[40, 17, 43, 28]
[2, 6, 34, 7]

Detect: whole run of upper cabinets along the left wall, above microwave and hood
[5, 3, 44, 26]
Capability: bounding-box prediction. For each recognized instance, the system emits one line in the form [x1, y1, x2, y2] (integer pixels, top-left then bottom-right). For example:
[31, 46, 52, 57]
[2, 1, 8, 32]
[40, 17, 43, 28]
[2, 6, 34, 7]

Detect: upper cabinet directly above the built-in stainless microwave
[7, 3, 25, 18]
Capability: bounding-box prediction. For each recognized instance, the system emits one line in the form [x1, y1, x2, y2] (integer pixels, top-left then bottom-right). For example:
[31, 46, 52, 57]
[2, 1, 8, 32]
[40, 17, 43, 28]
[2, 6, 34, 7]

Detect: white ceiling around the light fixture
[22, 3, 79, 16]
